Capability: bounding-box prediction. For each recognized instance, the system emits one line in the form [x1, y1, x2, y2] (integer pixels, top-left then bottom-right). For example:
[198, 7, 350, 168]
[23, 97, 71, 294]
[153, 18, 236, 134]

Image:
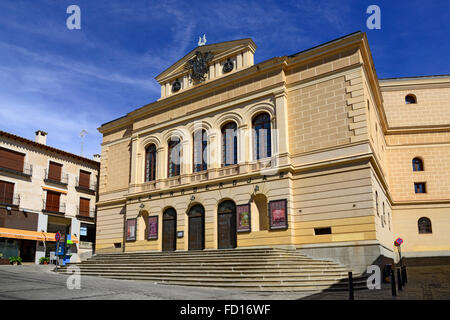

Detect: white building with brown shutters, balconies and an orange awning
[0, 130, 100, 263]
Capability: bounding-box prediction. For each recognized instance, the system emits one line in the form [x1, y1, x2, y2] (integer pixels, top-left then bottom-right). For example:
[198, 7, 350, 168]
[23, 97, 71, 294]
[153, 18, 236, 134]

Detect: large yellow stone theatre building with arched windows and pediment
[96, 32, 450, 272]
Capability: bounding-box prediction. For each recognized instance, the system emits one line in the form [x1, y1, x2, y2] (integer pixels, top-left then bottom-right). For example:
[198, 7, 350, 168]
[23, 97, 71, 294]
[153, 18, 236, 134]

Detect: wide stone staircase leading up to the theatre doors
[58, 248, 366, 292]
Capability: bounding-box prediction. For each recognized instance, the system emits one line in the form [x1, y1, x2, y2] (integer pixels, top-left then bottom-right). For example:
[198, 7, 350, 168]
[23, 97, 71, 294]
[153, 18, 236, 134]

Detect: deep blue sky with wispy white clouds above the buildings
[0, 0, 450, 157]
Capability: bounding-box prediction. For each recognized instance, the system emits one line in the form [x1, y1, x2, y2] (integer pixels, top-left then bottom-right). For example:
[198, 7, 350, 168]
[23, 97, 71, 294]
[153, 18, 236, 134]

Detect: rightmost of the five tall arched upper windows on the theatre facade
[252, 113, 272, 160]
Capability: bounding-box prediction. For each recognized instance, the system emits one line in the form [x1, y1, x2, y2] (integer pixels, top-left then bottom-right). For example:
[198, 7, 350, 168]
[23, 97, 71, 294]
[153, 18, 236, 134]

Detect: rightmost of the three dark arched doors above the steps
[217, 200, 237, 249]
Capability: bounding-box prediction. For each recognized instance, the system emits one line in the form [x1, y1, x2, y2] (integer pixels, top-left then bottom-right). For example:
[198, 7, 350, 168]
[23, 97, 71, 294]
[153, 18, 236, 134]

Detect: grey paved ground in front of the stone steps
[0, 265, 450, 300]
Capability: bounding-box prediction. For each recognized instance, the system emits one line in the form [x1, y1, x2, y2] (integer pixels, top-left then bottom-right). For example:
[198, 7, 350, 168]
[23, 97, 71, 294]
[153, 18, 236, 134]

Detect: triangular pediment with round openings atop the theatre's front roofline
[155, 38, 256, 98]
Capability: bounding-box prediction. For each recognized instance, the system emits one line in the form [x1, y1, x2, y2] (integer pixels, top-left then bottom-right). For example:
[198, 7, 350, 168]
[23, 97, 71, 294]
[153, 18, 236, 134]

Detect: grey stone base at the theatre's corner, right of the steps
[297, 241, 395, 274]
